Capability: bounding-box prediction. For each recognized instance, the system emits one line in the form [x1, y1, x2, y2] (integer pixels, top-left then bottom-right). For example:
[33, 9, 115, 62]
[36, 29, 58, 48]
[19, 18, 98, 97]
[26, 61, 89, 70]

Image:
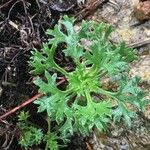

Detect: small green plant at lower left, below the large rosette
[17, 111, 59, 150]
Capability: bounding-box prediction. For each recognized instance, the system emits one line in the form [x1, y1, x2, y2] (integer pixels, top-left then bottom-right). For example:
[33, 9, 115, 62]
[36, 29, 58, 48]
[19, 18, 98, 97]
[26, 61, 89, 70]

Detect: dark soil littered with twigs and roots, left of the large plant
[0, 0, 85, 150]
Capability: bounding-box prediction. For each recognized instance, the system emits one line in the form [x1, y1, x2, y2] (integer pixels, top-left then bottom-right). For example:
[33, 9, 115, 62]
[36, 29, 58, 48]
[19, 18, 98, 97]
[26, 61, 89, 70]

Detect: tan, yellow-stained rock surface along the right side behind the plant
[91, 0, 150, 150]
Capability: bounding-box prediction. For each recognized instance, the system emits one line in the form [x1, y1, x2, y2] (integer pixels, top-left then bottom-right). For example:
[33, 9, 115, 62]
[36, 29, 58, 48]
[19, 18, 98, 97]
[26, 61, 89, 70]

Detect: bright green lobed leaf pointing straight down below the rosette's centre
[74, 101, 112, 134]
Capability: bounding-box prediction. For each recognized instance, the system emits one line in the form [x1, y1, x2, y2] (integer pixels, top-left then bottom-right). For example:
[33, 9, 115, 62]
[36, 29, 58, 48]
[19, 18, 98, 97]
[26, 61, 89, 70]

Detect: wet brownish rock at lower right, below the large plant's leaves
[92, 119, 150, 150]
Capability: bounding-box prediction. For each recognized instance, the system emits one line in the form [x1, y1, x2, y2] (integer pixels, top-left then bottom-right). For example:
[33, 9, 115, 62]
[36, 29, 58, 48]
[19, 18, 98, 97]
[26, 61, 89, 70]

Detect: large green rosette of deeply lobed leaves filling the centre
[17, 16, 146, 149]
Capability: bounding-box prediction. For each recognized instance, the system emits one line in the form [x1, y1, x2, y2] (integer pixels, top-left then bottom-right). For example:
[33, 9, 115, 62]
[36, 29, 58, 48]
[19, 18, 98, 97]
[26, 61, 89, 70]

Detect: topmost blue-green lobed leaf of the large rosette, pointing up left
[47, 16, 83, 61]
